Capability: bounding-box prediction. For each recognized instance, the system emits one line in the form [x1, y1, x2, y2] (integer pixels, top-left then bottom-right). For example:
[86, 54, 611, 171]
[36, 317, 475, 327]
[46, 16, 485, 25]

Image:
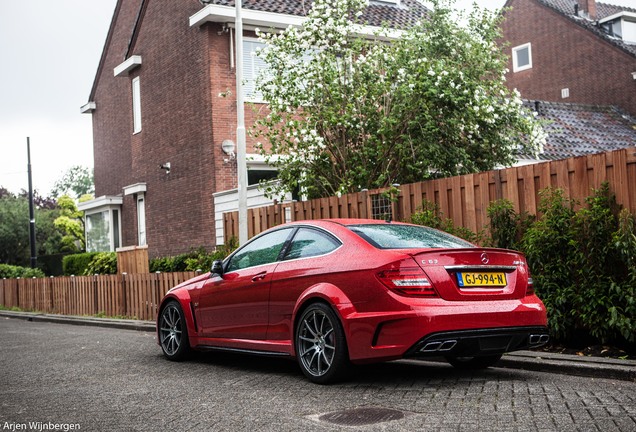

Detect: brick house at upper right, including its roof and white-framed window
[502, 0, 636, 117]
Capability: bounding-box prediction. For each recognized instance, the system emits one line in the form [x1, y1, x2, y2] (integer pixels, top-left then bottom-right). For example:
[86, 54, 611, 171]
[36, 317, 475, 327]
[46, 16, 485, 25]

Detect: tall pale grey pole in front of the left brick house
[234, 0, 247, 246]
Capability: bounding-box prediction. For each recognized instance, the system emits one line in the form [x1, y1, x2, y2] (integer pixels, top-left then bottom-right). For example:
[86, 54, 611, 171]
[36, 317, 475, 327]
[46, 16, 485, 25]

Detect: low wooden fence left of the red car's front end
[0, 272, 197, 320]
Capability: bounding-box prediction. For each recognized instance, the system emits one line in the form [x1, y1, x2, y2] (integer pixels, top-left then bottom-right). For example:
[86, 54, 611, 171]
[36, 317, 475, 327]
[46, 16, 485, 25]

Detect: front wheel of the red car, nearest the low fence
[159, 300, 192, 361]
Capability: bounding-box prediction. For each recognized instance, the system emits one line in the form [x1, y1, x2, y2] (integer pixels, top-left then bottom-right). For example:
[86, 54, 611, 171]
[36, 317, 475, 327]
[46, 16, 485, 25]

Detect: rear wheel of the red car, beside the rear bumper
[294, 303, 350, 384]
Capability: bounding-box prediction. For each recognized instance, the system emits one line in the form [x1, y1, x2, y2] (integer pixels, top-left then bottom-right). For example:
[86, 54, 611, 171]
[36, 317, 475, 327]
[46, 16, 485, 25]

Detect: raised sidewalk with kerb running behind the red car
[0, 311, 636, 382]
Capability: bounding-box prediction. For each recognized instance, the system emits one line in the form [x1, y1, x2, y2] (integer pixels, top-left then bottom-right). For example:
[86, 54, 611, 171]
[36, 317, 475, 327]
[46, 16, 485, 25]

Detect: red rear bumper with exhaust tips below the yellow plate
[343, 296, 548, 363]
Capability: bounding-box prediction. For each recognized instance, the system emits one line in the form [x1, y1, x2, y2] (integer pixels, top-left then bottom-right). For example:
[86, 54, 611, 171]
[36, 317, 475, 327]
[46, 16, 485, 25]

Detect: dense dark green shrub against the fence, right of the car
[522, 183, 636, 343]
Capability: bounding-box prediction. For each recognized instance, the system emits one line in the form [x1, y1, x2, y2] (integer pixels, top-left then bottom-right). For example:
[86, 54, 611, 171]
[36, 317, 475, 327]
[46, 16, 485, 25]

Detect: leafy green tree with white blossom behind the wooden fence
[252, 0, 545, 198]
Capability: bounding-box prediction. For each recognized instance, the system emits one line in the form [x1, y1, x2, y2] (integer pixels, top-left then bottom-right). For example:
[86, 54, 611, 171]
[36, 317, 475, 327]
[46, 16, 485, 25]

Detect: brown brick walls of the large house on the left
[93, 0, 276, 257]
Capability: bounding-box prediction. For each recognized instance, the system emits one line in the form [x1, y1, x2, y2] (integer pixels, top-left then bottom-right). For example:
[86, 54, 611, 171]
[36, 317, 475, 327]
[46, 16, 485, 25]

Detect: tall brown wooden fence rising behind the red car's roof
[223, 147, 636, 239]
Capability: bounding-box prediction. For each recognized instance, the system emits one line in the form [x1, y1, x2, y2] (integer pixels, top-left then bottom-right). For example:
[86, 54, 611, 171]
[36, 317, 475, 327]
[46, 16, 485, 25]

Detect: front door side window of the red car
[225, 228, 292, 272]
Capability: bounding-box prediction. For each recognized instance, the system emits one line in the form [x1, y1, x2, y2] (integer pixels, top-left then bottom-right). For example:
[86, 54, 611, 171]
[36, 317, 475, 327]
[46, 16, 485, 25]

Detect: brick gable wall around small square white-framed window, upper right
[503, 0, 636, 116]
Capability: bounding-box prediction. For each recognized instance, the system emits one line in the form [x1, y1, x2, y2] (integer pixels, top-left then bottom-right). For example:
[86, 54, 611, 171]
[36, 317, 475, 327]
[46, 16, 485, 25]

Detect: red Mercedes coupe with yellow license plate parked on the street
[157, 219, 548, 383]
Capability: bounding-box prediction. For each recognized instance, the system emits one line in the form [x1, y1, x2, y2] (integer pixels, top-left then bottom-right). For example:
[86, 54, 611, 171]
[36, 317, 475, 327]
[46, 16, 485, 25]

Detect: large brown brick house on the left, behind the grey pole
[79, 0, 426, 257]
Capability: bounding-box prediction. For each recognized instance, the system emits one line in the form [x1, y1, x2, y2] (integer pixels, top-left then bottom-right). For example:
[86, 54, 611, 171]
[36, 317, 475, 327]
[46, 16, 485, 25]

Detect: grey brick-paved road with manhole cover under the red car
[0, 318, 636, 432]
